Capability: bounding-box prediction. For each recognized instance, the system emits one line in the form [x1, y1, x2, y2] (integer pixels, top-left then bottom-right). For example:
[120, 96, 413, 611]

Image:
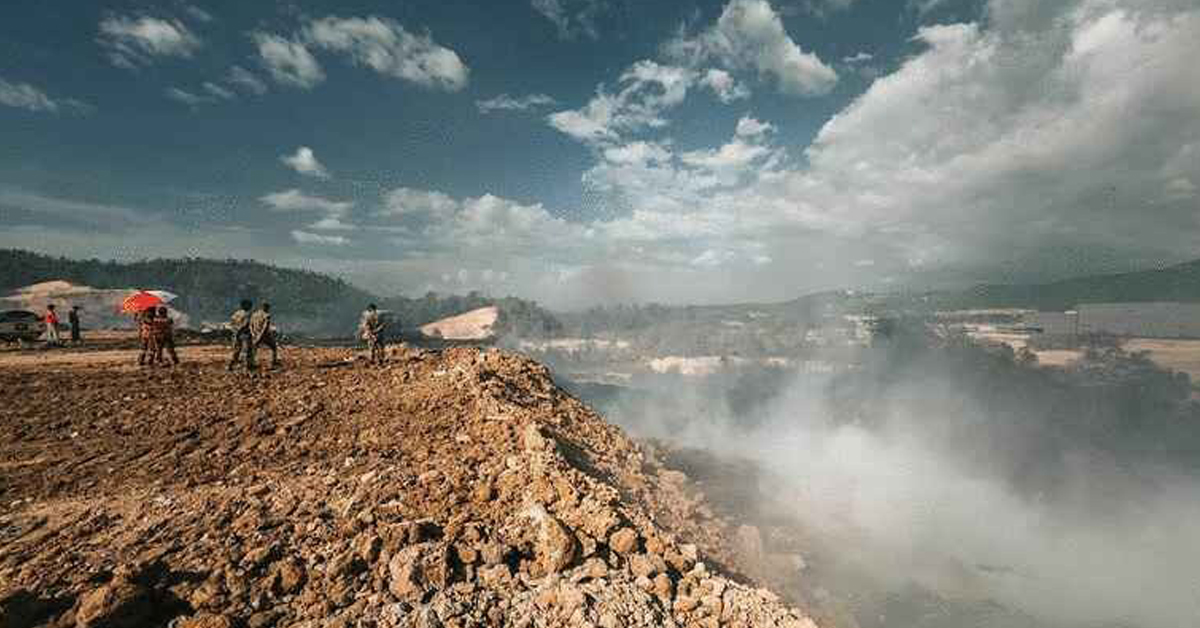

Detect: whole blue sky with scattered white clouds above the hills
[0, 0, 1200, 307]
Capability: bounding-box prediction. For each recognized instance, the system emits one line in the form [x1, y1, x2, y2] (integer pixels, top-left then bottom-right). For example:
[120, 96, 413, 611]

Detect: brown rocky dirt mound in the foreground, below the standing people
[0, 349, 812, 628]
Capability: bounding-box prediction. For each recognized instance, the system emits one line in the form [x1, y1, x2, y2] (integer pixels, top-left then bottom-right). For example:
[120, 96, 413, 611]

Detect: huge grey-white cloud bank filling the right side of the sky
[530, 0, 1200, 306]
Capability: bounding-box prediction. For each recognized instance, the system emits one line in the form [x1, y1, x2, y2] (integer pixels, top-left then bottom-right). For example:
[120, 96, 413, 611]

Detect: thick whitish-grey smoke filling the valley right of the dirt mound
[585, 338, 1200, 628]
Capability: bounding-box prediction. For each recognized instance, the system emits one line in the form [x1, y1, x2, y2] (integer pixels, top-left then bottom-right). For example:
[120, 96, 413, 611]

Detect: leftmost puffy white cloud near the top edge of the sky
[97, 16, 204, 70]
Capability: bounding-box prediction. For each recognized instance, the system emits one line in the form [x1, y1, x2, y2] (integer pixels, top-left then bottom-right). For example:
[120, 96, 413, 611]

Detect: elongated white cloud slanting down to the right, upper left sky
[305, 17, 470, 91]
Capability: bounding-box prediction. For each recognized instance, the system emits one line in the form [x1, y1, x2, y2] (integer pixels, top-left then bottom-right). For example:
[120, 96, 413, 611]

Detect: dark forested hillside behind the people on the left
[0, 249, 560, 336]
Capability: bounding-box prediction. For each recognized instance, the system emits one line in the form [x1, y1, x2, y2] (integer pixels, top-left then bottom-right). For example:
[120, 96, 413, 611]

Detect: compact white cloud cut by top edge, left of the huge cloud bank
[664, 0, 838, 96]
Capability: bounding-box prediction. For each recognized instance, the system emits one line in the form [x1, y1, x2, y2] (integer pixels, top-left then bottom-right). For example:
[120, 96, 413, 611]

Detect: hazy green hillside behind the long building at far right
[935, 259, 1200, 311]
